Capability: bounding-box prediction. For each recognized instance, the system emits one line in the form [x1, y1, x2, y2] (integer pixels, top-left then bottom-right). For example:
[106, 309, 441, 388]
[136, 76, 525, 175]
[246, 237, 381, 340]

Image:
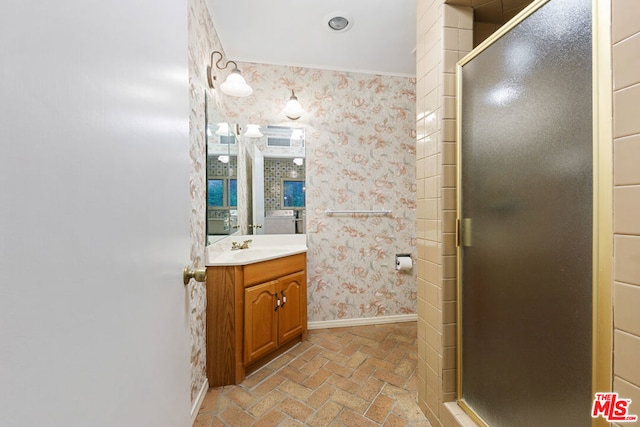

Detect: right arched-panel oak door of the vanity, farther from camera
[278, 271, 307, 344]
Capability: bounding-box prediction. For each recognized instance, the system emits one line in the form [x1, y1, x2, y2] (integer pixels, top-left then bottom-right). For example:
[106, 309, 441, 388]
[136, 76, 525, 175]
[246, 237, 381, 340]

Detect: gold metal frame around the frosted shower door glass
[456, 0, 613, 427]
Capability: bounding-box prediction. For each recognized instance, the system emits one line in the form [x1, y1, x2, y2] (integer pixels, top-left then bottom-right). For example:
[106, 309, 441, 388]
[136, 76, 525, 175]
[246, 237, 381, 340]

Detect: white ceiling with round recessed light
[206, 0, 416, 77]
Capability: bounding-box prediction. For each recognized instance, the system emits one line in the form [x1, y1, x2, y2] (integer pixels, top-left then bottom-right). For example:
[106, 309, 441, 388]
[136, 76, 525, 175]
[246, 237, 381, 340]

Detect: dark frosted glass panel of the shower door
[459, 0, 593, 427]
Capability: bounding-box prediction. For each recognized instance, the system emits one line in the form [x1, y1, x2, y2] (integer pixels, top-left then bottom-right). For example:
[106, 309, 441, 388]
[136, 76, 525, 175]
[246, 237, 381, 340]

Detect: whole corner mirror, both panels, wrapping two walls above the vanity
[205, 95, 306, 244]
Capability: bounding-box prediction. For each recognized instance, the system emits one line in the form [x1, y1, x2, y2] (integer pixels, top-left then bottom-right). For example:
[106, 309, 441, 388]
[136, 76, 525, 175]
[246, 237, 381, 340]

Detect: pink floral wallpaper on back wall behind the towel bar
[223, 63, 417, 321]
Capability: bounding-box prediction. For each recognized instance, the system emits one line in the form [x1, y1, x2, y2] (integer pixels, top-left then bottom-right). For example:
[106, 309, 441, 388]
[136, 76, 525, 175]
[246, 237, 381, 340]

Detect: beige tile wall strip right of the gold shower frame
[612, 0, 640, 425]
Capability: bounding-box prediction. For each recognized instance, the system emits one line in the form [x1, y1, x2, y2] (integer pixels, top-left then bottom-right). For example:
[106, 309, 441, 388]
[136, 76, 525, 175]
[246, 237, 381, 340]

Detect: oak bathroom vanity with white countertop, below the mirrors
[206, 235, 307, 387]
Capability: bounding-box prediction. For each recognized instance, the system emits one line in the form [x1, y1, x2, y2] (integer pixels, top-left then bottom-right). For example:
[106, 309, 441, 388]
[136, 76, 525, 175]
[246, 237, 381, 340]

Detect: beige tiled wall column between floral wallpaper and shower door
[416, 0, 473, 425]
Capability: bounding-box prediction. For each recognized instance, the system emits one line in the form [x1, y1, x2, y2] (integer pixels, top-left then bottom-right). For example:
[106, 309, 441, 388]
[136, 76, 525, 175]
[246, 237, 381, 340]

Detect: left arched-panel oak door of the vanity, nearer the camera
[244, 280, 280, 364]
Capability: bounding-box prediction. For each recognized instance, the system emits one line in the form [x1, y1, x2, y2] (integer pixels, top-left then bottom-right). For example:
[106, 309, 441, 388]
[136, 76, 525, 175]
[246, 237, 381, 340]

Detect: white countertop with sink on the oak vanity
[205, 234, 307, 266]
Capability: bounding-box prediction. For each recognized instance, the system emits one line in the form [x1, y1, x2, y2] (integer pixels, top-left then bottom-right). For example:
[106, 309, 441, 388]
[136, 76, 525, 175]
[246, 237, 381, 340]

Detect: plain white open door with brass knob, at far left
[0, 0, 190, 427]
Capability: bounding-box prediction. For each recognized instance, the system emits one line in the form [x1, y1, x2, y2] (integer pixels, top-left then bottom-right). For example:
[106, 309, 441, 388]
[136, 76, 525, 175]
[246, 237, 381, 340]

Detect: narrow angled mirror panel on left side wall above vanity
[205, 95, 238, 244]
